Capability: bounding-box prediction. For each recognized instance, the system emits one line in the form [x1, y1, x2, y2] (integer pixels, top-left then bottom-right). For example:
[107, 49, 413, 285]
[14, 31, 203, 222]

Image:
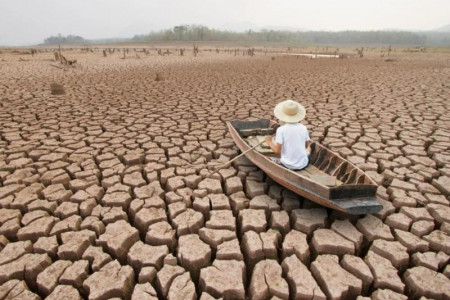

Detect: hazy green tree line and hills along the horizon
[44, 25, 450, 46]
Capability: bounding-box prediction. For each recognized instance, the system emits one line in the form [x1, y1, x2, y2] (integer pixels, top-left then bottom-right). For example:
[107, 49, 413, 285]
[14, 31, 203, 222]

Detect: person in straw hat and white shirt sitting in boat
[265, 100, 311, 171]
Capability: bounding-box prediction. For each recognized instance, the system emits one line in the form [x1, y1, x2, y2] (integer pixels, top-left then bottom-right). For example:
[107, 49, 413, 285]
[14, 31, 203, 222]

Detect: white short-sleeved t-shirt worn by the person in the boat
[275, 123, 309, 170]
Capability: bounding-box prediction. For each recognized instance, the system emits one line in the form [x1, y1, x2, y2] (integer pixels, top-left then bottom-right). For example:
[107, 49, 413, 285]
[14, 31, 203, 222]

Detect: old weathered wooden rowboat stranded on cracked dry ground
[227, 119, 383, 215]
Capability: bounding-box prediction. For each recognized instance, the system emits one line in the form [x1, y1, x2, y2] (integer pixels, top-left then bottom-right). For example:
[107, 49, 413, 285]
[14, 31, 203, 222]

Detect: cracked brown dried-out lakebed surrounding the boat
[0, 50, 450, 299]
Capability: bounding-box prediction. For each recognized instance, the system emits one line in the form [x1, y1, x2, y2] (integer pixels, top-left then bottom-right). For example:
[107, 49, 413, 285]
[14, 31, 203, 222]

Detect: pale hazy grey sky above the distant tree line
[0, 0, 450, 45]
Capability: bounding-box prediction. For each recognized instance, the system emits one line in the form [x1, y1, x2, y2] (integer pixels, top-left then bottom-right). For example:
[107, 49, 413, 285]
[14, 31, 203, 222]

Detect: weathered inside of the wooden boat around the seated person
[232, 120, 373, 187]
